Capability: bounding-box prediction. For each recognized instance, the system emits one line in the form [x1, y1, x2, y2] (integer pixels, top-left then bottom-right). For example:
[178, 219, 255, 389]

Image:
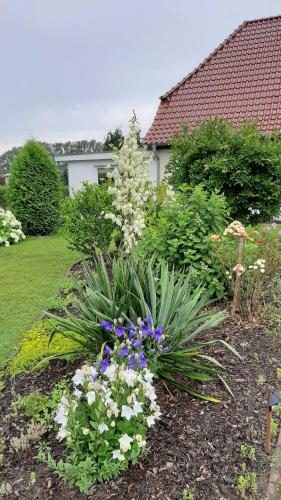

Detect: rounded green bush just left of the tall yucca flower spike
[63, 182, 114, 255]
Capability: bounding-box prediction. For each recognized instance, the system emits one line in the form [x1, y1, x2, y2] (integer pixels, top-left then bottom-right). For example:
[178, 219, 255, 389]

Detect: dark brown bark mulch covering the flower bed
[0, 306, 281, 500]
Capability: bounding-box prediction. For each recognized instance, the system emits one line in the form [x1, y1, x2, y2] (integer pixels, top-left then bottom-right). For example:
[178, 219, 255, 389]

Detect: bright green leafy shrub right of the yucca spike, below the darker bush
[138, 186, 228, 298]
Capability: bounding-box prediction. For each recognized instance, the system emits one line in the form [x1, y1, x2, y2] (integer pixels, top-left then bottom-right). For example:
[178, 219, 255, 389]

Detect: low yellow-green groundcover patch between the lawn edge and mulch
[7, 320, 84, 376]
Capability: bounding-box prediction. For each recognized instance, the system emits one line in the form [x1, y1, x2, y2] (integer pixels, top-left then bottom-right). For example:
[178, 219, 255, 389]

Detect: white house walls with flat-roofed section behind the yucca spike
[55, 151, 160, 194]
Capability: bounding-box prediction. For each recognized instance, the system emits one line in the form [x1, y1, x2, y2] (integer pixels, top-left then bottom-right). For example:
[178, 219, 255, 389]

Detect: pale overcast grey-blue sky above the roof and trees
[0, 0, 281, 152]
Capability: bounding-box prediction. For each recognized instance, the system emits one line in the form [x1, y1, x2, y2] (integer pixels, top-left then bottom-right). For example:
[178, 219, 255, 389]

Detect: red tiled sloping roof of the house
[143, 15, 281, 144]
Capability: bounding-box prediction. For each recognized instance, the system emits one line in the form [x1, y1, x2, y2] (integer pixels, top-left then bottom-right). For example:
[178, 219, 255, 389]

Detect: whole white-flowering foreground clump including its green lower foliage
[51, 323, 162, 491]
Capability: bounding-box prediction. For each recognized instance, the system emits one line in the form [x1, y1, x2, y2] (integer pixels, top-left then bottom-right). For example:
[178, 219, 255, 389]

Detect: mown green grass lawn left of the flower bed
[0, 233, 80, 365]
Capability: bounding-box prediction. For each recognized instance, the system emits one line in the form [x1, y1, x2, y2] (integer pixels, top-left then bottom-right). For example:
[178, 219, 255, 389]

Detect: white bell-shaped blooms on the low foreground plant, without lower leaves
[55, 359, 161, 461]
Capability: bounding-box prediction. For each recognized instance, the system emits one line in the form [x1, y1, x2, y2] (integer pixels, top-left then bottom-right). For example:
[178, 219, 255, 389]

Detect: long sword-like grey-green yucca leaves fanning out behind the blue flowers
[49, 257, 237, 401]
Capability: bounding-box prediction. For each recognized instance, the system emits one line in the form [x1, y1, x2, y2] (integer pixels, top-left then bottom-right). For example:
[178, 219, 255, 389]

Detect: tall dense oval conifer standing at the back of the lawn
[8, 140, 61, 235]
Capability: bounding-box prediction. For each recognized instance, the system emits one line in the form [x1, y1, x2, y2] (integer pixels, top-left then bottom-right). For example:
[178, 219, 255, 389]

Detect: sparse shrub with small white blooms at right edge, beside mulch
[213, 223, 281, 319]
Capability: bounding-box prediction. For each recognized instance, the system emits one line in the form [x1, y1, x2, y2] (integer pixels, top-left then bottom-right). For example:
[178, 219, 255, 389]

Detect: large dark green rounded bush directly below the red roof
[167, 118, 281, 223]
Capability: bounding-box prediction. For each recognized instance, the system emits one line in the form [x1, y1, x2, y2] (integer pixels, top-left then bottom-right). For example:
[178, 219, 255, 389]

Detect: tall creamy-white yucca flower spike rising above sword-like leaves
[105, 117, 152, 253]
